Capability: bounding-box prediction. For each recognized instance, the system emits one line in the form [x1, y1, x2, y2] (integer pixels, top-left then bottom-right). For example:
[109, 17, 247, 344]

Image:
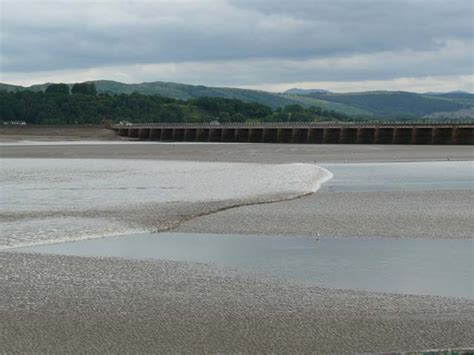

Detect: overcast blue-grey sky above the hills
[0, 0, 474, 92]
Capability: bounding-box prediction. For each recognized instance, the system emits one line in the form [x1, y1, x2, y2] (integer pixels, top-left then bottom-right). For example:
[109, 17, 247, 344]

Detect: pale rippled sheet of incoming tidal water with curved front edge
[0, 159, 332, 249]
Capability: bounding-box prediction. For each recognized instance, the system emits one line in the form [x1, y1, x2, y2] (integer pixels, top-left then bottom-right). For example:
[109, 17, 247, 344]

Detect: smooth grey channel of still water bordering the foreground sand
[12, 233, 474, 299]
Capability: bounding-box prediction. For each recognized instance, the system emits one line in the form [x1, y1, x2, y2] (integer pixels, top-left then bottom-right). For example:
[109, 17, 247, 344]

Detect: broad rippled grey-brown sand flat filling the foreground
[0, 253, 474, 353]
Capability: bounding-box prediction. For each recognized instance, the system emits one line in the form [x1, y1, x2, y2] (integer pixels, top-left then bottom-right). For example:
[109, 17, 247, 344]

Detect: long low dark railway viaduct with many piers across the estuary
[112, 122, 474, 145]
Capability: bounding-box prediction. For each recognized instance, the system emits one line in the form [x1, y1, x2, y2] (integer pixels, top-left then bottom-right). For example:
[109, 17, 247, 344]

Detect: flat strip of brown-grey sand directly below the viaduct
[0, 142, 474, 163]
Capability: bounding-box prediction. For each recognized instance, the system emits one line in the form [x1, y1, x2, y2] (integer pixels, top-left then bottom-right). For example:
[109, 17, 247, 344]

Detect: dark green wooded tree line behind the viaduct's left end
[0, 82, 352, 124]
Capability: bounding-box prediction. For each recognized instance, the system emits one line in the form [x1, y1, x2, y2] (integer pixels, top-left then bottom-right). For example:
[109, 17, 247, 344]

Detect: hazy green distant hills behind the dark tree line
[0, 80, 474, 119]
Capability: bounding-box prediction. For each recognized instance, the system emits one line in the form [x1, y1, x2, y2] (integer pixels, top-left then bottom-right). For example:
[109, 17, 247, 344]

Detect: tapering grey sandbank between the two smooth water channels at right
[177, 190, 474, 239]
